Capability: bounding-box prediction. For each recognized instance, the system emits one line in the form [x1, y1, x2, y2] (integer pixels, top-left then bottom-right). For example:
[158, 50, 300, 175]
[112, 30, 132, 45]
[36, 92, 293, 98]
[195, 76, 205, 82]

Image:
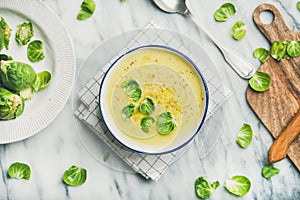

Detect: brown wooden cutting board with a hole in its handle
[246, 4, 300, 170]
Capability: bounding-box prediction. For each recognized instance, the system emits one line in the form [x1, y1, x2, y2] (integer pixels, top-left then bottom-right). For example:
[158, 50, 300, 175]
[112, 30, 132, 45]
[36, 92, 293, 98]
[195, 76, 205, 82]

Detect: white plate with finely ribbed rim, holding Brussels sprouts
[0, 0, 76, 144]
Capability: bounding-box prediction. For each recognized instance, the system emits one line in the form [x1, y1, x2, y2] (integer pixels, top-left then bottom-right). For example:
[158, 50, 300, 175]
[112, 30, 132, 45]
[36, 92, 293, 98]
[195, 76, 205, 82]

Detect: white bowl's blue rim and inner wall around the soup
[99, 45, 209, 154]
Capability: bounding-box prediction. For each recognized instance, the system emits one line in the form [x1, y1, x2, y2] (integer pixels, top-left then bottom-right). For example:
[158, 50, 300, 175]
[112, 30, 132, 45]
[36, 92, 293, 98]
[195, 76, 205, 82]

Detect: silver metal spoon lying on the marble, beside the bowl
[153, 0, 256, 79]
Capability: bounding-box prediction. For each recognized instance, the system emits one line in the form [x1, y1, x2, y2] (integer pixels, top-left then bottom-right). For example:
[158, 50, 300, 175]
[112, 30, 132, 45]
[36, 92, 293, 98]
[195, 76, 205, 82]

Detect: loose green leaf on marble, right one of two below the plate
[63, 165, 87, 186]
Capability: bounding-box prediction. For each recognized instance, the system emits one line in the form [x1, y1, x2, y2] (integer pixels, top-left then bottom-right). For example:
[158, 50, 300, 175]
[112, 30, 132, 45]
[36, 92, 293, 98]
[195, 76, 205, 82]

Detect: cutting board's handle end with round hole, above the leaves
[253, 4, 294, 43]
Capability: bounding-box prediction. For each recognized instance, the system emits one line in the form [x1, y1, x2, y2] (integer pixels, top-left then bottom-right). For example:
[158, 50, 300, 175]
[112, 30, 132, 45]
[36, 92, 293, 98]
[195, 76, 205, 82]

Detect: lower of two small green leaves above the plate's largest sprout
[27, 40, 45, 62]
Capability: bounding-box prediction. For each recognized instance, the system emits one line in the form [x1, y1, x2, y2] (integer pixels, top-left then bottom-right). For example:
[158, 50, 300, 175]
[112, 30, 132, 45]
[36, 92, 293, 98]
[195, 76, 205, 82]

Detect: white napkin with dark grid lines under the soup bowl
[74, 22, 231, 181]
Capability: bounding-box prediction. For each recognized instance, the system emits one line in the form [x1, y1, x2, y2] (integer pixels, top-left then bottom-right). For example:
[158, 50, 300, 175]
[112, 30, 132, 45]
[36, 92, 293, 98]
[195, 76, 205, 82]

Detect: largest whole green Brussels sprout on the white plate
[0, 61, 37, 93]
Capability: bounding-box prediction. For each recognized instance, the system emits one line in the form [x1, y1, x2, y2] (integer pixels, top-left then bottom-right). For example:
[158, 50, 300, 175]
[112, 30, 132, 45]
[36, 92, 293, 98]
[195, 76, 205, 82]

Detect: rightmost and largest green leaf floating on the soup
[157, 112, 176, 135]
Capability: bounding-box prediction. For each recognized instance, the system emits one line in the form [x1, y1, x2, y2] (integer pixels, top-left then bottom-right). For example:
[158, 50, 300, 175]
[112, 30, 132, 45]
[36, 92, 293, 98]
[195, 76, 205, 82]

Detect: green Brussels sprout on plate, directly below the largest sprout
[0, 88, 25, 120]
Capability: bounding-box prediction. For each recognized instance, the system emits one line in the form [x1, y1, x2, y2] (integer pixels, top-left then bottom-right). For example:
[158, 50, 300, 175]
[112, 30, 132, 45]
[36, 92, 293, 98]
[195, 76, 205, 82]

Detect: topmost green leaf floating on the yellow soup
[121, 79, 142, 101]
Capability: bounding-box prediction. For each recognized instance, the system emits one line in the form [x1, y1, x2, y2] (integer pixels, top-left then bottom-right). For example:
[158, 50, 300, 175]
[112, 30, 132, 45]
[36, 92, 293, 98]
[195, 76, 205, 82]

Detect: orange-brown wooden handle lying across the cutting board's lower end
[268, 111, 300, 163]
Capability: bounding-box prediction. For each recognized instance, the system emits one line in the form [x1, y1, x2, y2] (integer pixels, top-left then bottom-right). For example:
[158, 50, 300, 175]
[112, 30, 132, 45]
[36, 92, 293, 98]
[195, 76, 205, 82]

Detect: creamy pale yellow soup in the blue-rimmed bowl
[104, 48, 205, 148]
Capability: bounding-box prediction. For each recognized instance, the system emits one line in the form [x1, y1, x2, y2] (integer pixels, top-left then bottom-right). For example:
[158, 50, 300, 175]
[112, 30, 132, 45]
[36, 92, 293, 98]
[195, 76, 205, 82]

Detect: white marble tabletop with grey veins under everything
[0, 0, 300, 200]
